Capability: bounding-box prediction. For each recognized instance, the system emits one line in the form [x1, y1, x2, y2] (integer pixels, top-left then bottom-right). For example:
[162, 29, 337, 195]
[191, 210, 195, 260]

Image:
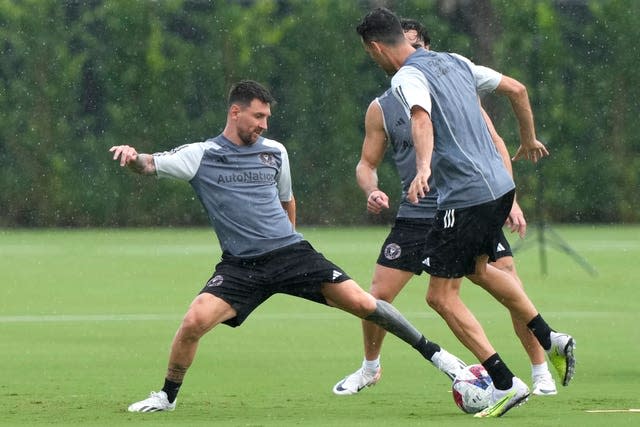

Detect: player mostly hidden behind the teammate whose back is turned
[333, 19, 557, 396]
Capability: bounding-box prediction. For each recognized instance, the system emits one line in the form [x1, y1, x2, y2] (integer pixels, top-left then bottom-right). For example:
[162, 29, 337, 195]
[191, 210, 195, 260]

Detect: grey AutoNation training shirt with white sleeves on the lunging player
[153, 135, 302, 257]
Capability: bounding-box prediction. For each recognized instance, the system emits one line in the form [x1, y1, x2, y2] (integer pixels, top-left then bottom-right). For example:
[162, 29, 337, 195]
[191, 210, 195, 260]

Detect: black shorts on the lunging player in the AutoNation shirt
[200, 240, 350, 327]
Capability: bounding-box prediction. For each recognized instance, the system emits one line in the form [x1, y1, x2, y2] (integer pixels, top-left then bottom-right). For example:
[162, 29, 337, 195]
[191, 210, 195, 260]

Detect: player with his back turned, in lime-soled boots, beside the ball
[357, 8, 575, 417]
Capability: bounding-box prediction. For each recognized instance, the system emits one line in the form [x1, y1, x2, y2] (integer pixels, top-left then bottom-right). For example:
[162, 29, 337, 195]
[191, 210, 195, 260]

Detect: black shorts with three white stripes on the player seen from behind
[423, 190, 515, 278]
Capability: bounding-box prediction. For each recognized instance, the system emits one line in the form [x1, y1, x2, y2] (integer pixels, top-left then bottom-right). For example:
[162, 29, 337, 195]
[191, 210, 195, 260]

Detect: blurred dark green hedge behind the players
[0, 0, 640, 226]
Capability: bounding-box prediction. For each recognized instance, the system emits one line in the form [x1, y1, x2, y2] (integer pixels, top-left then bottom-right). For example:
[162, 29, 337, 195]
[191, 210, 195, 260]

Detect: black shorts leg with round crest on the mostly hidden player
[377, 218, 433, 275]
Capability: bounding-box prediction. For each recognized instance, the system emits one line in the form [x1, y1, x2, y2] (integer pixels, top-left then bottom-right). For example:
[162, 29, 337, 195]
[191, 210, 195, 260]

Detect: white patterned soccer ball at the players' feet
[451, 365, 493, 414]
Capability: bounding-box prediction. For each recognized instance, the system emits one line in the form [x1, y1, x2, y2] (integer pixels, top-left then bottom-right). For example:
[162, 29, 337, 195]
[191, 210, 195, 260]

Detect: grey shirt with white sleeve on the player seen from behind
[391, 49, 515, 210]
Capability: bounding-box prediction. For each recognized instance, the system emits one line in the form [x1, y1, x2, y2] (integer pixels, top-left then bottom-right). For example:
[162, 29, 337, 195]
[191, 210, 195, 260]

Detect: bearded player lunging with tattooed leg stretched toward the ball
[110, 80, 464, 412]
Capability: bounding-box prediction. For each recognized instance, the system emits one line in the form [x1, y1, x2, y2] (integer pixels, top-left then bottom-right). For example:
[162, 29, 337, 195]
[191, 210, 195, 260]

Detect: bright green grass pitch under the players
[0, 226, 640, 426]
